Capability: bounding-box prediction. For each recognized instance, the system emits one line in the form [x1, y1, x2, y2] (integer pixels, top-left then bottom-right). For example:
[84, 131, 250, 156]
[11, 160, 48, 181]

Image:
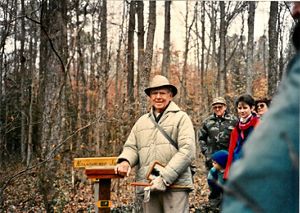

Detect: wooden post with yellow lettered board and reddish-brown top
[73, 157, 123, 213]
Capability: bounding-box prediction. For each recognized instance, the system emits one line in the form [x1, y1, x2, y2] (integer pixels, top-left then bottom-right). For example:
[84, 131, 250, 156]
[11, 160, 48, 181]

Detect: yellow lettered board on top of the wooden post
[73, 157, 117, 168]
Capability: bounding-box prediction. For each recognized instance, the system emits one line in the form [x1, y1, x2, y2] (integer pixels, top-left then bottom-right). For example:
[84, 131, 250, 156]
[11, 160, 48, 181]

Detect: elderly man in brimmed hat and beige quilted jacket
[115, 75, 196, 213]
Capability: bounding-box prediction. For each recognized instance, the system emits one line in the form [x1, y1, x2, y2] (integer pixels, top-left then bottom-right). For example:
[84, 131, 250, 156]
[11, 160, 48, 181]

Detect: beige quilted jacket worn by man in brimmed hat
[118, 102, 196, 191]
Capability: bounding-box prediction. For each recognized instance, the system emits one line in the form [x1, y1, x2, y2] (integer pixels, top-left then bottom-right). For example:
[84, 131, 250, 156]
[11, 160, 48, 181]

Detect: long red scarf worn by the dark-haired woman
[224, 116, 259, 179]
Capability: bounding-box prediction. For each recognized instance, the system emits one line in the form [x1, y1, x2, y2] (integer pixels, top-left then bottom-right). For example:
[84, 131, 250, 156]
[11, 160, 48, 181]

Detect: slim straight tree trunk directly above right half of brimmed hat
[161, 0, 171, 78]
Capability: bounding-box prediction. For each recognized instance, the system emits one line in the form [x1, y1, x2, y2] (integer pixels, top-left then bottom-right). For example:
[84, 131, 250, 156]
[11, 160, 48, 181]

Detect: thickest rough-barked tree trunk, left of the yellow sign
[39, 0, 68, 212]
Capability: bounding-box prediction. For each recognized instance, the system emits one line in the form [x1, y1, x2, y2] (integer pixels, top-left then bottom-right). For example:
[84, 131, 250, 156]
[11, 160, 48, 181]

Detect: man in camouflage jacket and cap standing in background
[198, 97, 238, 170]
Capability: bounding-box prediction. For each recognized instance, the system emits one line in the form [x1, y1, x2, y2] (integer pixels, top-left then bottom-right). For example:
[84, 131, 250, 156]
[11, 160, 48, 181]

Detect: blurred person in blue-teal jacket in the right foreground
[222, 2, 300, 213]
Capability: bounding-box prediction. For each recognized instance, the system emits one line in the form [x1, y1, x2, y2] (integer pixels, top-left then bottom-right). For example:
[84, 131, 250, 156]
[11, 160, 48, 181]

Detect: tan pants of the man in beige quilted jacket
[143, 191, 189, 213]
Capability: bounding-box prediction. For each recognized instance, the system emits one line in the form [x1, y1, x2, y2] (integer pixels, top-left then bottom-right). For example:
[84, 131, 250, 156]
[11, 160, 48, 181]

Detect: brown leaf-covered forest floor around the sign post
[0, 156, 209, 213]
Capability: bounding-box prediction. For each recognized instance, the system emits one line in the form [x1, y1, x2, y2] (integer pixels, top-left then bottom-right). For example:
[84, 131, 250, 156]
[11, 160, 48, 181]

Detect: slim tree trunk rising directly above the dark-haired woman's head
[246, 1, 255, 95]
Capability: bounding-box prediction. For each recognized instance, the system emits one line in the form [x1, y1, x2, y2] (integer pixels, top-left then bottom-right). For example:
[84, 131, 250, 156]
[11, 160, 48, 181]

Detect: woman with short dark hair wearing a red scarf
[224, 94, 259, 179]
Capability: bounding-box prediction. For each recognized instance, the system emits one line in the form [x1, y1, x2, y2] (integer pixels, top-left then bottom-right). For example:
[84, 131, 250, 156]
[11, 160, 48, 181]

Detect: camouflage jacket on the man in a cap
[198, 112, 238, 158]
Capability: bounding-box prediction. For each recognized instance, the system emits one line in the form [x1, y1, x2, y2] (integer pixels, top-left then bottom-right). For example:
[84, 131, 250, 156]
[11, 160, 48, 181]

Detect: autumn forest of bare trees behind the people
[0, 0, 294, 212]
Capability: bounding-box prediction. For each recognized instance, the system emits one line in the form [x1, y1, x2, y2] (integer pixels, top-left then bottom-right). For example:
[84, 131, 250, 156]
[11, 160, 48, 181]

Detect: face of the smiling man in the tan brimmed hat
[150, 88, 173, 113]
